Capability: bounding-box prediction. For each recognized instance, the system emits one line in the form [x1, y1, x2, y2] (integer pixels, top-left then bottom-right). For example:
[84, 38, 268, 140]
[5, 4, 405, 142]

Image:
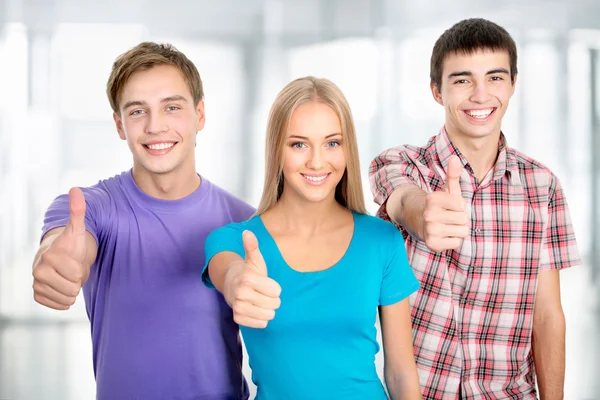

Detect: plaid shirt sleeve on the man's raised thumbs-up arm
[369, 146, 426, 221]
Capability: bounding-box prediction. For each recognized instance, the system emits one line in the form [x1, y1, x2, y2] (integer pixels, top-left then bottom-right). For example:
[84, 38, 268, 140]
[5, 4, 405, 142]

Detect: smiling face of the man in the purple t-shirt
[113, 65, 204, 176]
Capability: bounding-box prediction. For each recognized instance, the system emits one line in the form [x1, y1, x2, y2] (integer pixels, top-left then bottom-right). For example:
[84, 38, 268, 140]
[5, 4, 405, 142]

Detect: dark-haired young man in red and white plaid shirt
[370, 19, 581, 400]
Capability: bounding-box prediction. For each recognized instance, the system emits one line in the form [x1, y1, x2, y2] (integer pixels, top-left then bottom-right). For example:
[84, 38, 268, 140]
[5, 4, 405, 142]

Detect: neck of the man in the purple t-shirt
[133, 161, 201, 200]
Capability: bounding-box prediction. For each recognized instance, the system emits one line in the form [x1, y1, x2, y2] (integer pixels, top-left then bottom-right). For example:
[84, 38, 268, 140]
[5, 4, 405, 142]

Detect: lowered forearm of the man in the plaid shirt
[532, 311, 566, 400]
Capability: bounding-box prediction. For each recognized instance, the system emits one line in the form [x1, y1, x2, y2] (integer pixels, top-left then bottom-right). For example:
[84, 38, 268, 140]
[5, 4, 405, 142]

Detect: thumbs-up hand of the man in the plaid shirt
[421, 155, 469, 252]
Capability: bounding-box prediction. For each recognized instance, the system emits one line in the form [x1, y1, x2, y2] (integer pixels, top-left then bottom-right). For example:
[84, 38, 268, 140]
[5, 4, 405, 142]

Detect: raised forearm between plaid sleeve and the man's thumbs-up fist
[386, 186, 427, 240]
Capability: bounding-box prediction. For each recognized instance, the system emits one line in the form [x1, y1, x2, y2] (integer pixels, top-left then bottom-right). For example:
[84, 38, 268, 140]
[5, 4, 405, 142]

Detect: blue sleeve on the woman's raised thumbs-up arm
[202, 223, 246, 289]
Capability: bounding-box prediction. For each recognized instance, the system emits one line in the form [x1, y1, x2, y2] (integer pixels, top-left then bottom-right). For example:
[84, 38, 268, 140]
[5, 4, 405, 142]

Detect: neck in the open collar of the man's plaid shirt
[446, 129, 500, 182]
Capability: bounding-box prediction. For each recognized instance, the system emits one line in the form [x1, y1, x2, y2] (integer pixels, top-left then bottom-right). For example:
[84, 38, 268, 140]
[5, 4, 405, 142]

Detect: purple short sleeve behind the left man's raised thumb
[40, 188, 102, 246]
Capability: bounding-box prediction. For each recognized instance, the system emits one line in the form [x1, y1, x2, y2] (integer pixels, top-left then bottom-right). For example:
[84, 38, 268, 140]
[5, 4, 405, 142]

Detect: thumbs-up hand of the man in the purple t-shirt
[33, 188, 89, 310]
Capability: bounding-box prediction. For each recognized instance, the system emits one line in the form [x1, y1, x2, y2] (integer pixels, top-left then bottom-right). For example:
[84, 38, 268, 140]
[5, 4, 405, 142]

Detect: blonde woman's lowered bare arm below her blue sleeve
[380, 299, 421, 400]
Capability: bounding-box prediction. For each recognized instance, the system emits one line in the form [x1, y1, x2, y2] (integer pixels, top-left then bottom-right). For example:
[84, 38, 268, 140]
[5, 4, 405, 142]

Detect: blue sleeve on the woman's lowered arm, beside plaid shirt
[379, 224, 420, 306]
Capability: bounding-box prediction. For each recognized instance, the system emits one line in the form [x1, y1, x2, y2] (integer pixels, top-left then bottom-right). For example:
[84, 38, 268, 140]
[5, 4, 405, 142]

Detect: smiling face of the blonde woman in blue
[282, 101, 346, 206]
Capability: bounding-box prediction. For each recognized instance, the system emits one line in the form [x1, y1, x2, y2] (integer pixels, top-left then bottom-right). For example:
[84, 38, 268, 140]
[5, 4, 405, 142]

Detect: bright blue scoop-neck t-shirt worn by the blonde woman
[203, 213, 419, 400]
